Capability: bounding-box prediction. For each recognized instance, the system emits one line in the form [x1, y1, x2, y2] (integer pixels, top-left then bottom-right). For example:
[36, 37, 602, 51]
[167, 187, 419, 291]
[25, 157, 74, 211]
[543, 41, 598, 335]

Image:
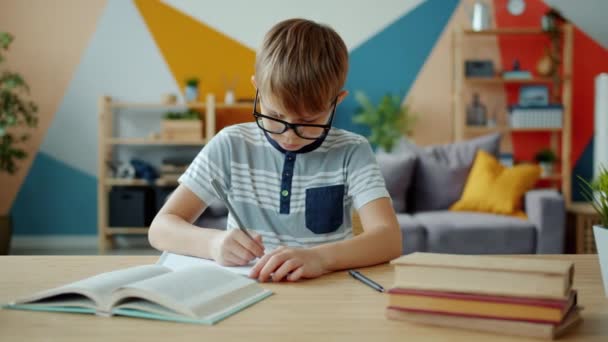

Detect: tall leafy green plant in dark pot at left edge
[0, 32, 38, 254]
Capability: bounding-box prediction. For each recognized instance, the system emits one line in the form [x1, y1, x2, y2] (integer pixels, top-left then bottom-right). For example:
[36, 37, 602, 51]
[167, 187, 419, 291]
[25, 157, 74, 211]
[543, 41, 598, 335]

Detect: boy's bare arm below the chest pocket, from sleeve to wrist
[311, 197, 402, 271]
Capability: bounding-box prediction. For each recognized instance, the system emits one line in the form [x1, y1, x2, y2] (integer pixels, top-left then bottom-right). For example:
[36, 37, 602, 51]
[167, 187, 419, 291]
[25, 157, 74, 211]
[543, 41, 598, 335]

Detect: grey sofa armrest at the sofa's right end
[525, 190, 566, 254]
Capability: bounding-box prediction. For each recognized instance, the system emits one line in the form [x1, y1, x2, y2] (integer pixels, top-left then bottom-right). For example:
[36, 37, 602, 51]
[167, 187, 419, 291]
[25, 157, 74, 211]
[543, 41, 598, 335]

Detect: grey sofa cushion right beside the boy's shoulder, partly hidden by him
[376, 152, 416, 213]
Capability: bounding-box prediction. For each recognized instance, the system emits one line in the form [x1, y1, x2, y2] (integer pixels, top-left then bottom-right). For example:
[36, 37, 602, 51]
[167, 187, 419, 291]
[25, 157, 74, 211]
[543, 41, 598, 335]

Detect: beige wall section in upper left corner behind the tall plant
[0, 0, 106, 215]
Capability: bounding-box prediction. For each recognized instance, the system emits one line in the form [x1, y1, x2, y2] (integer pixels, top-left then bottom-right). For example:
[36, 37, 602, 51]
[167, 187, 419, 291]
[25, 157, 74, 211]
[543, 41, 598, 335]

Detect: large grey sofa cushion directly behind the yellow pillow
[408, 133, 500, 212]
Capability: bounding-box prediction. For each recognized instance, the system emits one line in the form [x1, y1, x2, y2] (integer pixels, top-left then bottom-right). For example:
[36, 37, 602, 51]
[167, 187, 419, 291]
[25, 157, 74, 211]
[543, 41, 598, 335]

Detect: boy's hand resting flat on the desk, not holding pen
[249, 246, 329, 282]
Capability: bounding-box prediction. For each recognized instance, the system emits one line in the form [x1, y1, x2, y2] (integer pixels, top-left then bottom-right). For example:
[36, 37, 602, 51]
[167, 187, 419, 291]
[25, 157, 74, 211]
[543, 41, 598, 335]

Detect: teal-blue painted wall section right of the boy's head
[335, 0, 459, 135]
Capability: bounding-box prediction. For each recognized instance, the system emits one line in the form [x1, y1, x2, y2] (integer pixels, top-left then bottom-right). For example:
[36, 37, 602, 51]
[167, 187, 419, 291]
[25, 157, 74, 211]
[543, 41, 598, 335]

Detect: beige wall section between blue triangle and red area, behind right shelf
[404, 0, 506, 145]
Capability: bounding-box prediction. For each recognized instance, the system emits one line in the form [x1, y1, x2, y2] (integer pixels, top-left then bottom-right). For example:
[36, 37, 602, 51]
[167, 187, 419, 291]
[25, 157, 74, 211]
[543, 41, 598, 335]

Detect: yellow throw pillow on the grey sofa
[450, 150, 541, 217]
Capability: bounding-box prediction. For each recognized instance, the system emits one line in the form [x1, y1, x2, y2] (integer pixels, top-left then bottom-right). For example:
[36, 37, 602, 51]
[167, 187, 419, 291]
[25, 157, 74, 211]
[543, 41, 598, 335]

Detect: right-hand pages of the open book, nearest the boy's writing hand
[112, 265, 266, 319]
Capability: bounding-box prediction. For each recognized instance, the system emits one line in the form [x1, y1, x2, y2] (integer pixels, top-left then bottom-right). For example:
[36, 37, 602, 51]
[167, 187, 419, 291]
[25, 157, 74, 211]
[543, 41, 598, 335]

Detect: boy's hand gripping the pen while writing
[211, 229, 264, 266]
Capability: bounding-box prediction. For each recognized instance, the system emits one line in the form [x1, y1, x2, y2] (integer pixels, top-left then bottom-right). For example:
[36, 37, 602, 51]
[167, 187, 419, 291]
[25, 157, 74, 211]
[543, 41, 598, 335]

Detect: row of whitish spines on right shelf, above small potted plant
[509, 104, 564, 128]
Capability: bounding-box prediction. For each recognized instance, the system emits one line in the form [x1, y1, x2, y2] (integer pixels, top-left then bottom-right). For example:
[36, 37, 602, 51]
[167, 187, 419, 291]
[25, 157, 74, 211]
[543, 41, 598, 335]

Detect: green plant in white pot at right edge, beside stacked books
[578, 166, 608, 297]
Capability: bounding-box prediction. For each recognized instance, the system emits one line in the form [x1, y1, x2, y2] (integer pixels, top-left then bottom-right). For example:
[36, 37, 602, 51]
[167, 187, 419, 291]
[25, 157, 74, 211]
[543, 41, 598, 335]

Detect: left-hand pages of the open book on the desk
[11, 265, 171, 307]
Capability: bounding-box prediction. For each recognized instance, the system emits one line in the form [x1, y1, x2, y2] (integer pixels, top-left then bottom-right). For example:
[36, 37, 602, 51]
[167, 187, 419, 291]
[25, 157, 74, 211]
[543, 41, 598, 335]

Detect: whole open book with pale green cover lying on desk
[5, 264, 272, 324]
